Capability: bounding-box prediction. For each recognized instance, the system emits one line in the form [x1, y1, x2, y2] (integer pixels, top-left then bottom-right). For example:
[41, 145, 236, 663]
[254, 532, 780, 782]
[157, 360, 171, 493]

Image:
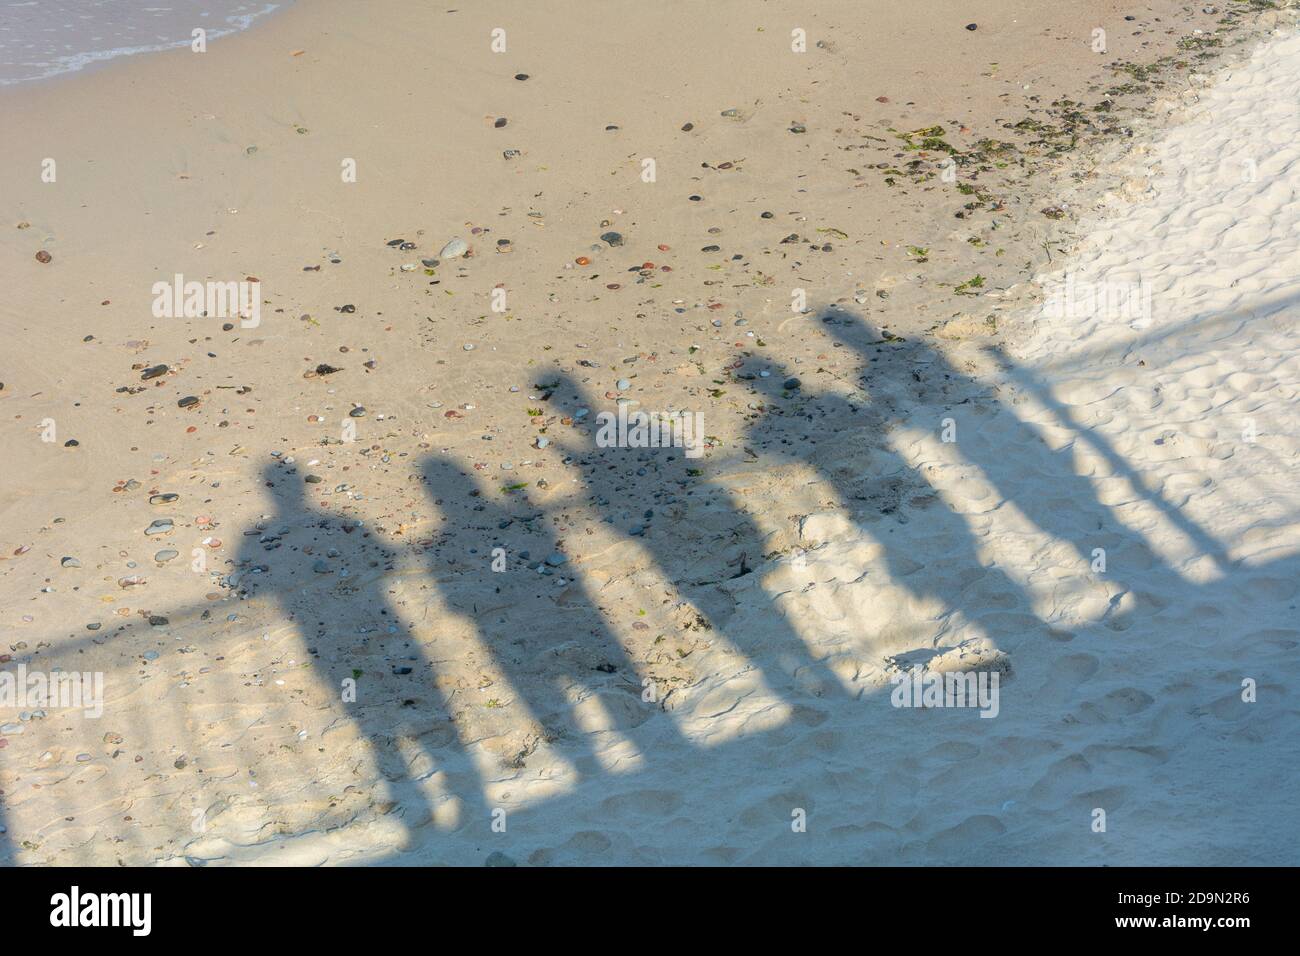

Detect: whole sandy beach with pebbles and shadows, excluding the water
[0, 0, 1300, 866]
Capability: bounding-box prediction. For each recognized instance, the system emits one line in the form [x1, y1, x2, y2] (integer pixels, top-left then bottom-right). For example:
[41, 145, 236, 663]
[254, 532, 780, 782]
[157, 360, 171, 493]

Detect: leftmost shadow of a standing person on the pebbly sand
[237, 466, 490, 847]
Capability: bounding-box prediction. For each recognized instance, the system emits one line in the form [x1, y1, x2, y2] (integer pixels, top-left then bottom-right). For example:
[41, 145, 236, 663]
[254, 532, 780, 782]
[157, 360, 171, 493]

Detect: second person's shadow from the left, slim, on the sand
[423, 457, 680, 777]
